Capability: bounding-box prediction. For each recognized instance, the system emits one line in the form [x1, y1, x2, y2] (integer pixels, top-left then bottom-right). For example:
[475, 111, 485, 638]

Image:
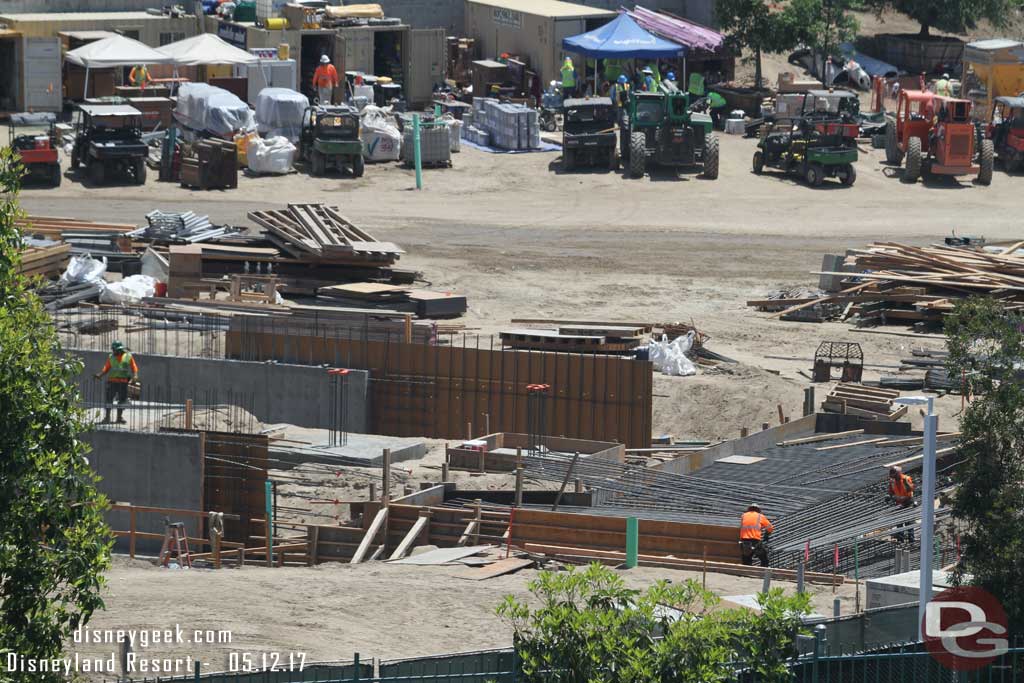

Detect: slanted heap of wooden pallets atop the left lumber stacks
[249, 204, 403, 265]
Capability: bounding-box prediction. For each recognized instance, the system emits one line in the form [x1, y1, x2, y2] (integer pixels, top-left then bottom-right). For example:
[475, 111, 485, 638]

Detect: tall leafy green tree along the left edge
[0, 148, 111, 683]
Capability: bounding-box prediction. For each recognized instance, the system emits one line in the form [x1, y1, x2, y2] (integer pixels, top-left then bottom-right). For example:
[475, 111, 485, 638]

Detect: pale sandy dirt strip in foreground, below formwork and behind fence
[74, 558, 864, 673]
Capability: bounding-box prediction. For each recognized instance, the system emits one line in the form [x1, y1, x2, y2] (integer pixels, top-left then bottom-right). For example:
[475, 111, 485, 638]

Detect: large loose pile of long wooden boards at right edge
[748, 242, 1024, 325]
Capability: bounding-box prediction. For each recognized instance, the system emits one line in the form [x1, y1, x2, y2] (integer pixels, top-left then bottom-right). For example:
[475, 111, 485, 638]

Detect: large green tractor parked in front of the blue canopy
[620, 86, 718, 180]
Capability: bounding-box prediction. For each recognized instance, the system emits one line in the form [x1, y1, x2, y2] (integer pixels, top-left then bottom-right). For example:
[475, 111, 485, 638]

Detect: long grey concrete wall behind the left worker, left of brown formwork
[73, 351, 370, 433]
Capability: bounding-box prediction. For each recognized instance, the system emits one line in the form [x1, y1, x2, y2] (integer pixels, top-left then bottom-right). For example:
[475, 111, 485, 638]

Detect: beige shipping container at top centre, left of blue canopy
[466, 0, 615, 83]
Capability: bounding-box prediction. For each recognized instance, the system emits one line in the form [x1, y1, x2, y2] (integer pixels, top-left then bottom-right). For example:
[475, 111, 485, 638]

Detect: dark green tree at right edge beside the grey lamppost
[945, 298, 1024, 633]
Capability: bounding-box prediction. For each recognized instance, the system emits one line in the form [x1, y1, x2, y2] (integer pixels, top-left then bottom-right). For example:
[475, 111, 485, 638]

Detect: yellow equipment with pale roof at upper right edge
[961, 38, 1024, 121]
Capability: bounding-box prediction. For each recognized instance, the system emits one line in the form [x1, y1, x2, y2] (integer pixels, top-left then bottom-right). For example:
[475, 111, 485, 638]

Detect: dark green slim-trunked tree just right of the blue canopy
[715, 0, 798, 88]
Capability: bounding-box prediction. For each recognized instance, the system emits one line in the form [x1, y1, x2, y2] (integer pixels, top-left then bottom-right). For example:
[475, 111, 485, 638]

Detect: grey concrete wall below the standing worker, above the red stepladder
[83, 429, 203, 555]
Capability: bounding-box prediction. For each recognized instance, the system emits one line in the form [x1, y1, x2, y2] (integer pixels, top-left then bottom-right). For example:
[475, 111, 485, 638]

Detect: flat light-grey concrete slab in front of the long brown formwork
[269, 425, 427, 469]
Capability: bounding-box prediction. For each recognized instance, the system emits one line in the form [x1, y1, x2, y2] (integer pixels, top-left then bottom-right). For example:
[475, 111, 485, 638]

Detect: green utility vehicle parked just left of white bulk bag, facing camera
[299, 105, 362, 178]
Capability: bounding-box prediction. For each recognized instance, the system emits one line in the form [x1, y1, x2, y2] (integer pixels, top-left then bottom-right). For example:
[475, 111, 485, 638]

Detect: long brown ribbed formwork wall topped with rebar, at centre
[225, 329, 653, 447]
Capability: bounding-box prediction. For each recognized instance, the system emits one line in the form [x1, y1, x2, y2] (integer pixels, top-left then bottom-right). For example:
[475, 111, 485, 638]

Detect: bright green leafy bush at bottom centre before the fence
[498, 564, 810, 683]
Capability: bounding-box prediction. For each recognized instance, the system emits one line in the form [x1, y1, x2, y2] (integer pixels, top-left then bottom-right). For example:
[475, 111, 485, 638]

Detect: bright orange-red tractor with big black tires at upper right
[886, 90, 994, 185]
